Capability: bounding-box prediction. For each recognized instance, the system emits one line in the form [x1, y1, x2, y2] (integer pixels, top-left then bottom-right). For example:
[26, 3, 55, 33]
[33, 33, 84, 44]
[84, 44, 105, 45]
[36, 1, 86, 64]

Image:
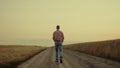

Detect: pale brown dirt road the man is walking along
[18, 48, 120, 68]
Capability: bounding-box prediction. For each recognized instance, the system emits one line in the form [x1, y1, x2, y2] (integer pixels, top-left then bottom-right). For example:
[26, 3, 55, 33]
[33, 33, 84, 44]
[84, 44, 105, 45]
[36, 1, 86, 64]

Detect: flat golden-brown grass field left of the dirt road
[0, 45, 46, 68]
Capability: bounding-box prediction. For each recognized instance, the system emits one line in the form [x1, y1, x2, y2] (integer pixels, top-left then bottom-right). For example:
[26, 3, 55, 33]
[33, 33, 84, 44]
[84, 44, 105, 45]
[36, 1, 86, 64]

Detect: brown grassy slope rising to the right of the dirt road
[64, 39, 120, 61]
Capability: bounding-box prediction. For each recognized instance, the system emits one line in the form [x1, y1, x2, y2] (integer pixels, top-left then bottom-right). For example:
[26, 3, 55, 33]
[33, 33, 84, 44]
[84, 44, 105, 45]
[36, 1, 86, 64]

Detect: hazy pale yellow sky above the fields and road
[0, 0, 120, 46]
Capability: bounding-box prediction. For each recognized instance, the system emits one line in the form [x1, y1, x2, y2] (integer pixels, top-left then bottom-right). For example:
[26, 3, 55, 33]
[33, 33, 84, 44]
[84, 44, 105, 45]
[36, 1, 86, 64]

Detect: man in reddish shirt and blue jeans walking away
[53, 25, 64, 63]
